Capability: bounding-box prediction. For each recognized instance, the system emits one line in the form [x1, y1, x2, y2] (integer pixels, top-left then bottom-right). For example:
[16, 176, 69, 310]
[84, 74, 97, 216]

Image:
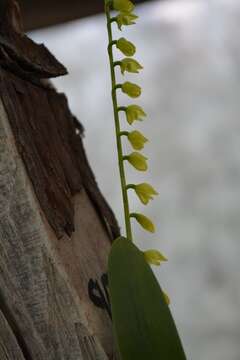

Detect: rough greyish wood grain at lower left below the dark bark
[0, 97, 110, 360]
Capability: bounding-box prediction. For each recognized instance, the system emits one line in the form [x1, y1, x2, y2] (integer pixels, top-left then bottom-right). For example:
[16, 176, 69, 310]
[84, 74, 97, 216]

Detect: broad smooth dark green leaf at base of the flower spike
[108, 237, 186, 360]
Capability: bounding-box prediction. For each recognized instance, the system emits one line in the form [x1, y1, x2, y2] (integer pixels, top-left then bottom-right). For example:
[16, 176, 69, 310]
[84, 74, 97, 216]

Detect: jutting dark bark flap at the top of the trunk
[0, 0, 67, 81]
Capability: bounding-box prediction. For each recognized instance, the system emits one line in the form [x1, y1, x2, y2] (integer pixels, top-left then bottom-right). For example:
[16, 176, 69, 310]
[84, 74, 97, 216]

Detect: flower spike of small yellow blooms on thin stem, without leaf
[105, 0, 168, 301]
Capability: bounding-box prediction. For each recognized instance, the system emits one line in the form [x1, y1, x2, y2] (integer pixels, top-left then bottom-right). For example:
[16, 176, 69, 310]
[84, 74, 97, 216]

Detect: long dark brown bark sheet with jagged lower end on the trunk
[0, 70, 118, 238]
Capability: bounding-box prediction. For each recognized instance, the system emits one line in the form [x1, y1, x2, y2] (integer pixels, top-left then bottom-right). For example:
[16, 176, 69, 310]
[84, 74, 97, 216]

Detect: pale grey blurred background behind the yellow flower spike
[30, 0, 240, 360]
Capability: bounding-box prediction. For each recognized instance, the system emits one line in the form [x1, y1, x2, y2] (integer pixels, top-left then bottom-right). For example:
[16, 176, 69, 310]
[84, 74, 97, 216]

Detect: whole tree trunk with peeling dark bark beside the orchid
[0, 0, 119, 360]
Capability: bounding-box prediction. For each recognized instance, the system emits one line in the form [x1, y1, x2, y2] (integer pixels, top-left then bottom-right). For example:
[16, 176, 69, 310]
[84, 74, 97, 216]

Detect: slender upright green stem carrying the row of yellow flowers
[105, 2, 132, 241]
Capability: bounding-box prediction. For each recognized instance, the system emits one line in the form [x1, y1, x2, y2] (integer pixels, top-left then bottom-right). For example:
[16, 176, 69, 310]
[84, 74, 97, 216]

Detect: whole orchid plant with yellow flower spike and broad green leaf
[105, 0, 186, 360]
